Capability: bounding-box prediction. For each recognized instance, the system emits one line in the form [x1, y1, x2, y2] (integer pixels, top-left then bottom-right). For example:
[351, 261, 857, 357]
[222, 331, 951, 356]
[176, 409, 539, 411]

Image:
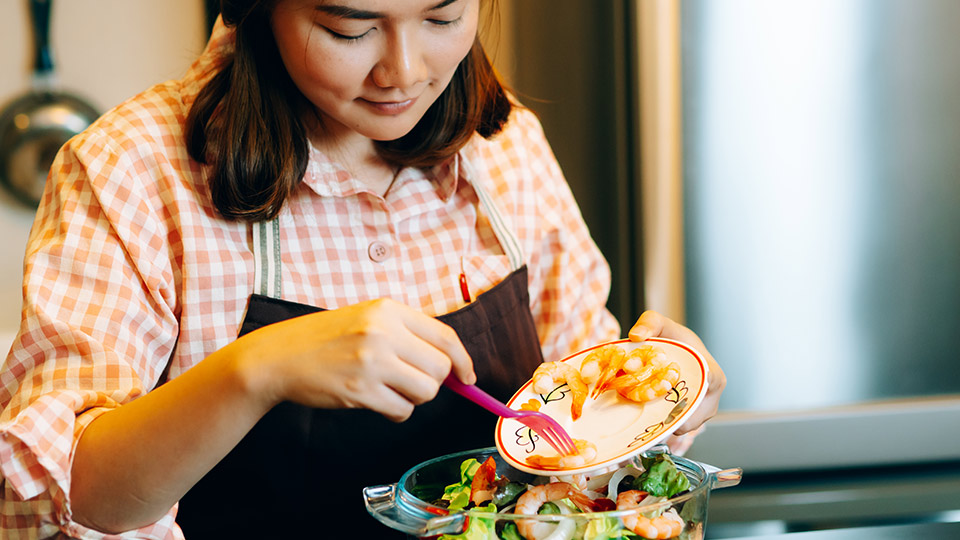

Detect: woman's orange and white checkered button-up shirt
[0, 20, 620, 539]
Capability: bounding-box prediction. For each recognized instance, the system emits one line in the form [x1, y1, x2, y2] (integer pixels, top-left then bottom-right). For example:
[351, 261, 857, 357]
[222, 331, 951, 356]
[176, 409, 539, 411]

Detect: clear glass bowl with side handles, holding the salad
[363, 446, 743, 540]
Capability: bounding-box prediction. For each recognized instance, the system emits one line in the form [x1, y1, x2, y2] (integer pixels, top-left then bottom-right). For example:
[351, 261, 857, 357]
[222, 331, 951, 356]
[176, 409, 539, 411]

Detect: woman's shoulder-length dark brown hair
[185, 0, 513, 221]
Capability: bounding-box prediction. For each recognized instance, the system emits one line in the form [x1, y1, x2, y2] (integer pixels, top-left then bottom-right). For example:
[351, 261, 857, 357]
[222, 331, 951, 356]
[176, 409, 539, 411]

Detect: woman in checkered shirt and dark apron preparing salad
[0, 0, 724, 538]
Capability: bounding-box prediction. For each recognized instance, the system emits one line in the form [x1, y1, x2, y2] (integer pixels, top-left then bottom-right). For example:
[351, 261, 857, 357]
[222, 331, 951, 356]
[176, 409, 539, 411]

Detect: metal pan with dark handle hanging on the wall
[0, 0, 99, 207]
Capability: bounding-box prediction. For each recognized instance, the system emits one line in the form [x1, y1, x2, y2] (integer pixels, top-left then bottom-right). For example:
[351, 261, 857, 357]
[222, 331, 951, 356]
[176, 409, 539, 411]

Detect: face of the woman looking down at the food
[271, 0, 480, 140]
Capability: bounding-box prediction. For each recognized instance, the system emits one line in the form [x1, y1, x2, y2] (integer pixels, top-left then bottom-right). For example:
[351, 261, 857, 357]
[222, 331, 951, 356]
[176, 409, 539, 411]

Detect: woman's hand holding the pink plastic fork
[227, 299, 476, 422]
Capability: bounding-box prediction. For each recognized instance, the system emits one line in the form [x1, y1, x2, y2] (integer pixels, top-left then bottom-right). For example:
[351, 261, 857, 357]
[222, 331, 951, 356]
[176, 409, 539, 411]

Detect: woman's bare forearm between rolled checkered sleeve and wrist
[70, 340, 274, 533]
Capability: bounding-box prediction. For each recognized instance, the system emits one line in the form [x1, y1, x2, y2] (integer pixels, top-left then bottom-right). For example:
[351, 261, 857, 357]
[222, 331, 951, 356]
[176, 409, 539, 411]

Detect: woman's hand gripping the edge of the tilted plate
[629, 311, 727, 435]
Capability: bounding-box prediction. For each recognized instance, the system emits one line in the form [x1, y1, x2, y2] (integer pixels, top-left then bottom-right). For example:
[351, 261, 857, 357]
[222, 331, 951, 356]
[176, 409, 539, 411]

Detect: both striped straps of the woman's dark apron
[253, 155, 524, 298]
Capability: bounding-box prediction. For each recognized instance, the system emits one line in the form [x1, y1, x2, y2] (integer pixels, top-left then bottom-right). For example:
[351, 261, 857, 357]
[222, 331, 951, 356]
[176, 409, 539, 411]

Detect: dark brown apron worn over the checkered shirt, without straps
[177, 176, 543, 540]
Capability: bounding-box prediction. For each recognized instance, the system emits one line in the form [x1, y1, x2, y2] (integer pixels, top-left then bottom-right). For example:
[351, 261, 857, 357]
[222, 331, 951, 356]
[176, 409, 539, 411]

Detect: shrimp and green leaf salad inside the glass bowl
[432, 454, 692, 540]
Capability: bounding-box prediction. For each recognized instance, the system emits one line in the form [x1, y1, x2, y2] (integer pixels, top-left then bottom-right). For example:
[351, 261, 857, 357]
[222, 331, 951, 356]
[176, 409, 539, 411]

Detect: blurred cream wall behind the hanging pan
[0, 0, 206, 353]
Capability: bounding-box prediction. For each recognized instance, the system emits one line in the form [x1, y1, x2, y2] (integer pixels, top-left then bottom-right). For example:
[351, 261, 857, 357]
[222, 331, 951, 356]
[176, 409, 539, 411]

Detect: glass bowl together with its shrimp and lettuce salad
[364, 446, 742, 540]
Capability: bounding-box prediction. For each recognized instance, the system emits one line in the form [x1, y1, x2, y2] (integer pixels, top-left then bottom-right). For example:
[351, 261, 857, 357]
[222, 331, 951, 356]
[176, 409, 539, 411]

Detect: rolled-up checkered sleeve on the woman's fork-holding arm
[0, 125, 180, 538]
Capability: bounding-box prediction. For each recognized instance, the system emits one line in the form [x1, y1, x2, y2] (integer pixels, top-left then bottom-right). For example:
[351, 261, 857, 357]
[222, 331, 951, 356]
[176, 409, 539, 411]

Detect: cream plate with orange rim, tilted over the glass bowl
[495, 337, 708, 476]
